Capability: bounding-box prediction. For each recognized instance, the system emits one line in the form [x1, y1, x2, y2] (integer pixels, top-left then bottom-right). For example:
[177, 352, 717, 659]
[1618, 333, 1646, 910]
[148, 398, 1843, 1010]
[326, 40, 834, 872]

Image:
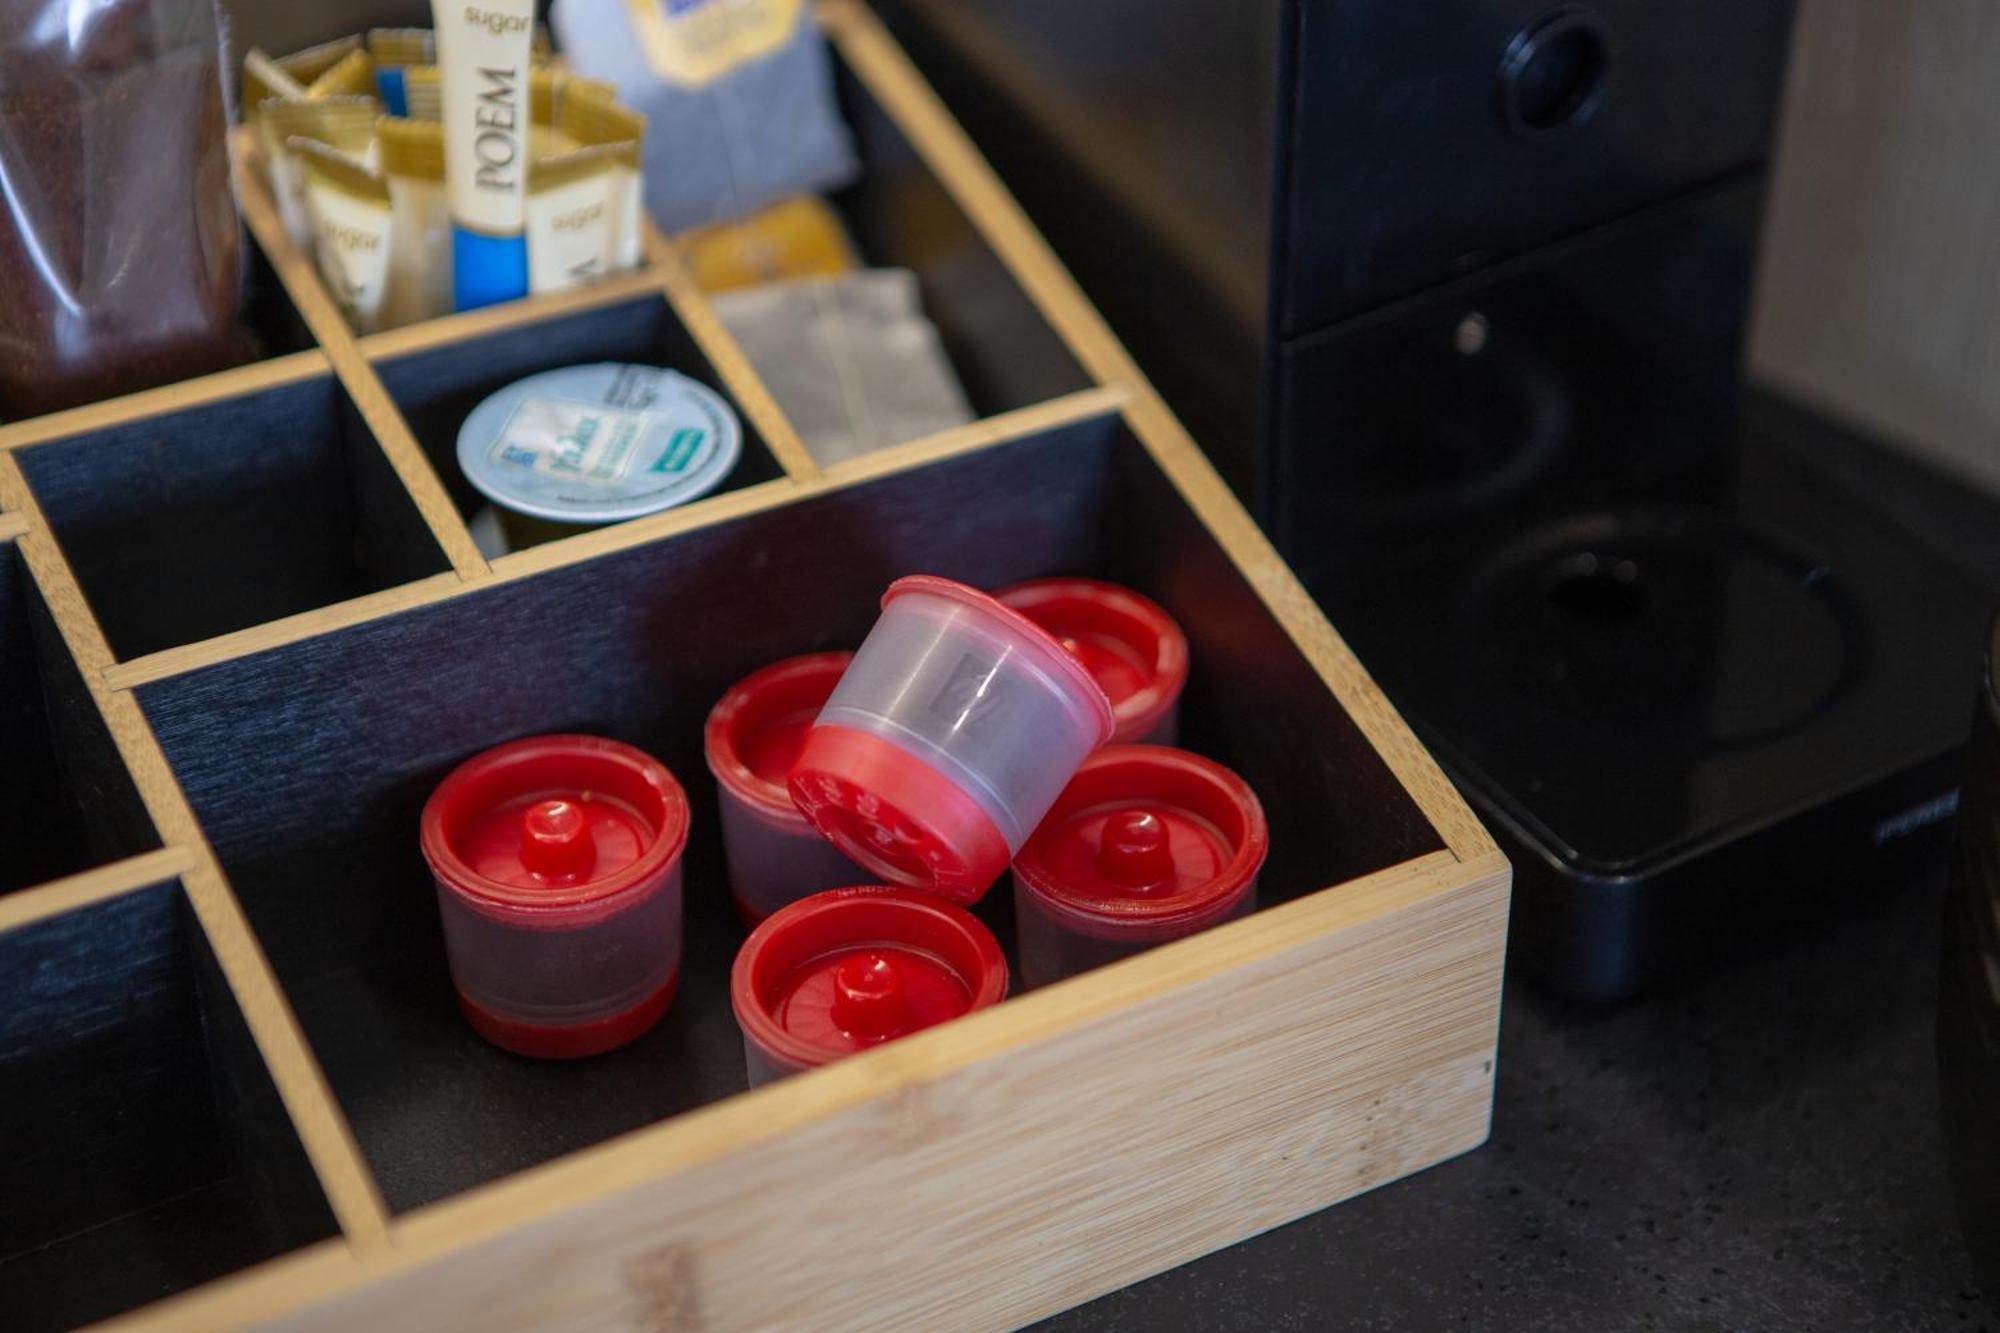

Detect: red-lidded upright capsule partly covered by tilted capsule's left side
[704, 652, 868, 927]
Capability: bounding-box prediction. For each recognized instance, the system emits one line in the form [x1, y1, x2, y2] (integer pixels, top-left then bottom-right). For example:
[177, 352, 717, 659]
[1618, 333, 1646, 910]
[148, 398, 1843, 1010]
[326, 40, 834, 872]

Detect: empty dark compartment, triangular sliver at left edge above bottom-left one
[0, 542, 160, 893]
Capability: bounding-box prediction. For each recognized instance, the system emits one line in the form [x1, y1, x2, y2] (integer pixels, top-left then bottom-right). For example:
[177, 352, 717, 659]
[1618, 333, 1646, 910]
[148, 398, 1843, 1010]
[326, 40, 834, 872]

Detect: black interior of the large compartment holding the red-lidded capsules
[140, 416, 1438, 1209]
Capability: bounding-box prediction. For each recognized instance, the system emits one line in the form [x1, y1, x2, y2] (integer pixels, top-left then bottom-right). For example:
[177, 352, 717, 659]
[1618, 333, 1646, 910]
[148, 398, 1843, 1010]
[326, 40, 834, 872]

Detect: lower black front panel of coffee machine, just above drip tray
[1266, 178, 1762, 556]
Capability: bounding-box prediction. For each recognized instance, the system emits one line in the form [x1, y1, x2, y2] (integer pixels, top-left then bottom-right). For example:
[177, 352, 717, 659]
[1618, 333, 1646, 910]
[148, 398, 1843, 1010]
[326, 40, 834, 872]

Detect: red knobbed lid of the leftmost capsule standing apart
[422, 737, 688, 929]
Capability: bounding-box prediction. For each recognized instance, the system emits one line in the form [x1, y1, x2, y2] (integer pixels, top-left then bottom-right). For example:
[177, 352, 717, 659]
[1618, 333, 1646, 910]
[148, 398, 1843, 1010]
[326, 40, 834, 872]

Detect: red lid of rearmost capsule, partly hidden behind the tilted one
[994, 578, 1188, 743]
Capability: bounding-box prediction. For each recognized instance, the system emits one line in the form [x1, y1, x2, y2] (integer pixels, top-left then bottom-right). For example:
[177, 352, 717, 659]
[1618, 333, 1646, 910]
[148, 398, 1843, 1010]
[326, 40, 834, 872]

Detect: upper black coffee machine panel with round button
[1276, 0, 1792, 334]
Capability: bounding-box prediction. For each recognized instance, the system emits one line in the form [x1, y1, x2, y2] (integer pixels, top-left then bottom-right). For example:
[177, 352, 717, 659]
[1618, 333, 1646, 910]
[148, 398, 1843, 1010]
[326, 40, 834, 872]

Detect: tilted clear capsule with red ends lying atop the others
[790, 574, 1112, 903]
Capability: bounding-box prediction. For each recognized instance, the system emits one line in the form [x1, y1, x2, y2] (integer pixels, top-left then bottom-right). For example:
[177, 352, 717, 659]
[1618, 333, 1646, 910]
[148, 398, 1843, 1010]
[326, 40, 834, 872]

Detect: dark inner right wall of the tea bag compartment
[832, 60, 1090, 416]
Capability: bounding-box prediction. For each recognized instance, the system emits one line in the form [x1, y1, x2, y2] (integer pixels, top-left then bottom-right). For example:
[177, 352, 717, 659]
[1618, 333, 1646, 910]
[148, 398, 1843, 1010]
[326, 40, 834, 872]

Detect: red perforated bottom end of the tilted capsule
[790, 725, 1012, 903]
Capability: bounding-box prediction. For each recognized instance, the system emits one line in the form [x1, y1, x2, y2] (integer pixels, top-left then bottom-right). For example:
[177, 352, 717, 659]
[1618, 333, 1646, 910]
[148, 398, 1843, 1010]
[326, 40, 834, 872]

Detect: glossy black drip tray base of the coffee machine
[1310, 394, 2000, 997]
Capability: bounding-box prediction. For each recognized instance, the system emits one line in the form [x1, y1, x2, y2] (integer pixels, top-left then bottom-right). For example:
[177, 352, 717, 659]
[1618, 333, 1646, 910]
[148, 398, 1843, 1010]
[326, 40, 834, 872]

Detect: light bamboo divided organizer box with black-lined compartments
[0, 2, 1508, 1329]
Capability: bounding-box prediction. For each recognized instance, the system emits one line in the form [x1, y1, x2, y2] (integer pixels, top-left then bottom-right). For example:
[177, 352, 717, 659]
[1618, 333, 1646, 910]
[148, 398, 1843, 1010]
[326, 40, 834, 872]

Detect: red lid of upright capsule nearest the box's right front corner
[1014, 745, 1270, 937]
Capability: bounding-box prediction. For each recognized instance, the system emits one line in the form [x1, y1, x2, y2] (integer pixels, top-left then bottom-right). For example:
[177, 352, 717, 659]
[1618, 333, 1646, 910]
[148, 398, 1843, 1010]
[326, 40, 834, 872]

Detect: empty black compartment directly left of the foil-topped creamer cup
[18, 374, 448, 660]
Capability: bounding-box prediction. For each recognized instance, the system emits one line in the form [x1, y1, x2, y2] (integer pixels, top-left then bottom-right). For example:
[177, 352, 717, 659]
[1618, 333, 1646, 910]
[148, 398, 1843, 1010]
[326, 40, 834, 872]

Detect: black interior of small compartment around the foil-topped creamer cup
[376, 296, 784, 516]
